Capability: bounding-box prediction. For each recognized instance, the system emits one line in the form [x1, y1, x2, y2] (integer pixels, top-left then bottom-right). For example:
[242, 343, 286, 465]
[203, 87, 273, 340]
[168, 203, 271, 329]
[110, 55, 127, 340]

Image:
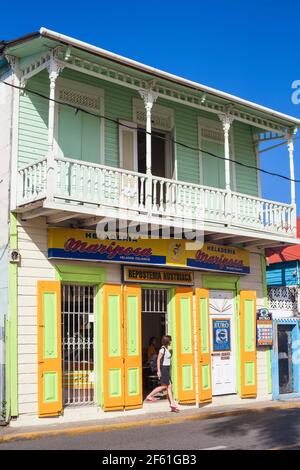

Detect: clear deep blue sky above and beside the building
[0, 0, 300, 210]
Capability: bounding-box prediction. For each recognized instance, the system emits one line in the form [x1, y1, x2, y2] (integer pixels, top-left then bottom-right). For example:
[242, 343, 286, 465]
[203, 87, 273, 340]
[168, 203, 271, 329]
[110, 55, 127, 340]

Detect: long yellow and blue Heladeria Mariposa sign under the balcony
[48, 228, 250, 274]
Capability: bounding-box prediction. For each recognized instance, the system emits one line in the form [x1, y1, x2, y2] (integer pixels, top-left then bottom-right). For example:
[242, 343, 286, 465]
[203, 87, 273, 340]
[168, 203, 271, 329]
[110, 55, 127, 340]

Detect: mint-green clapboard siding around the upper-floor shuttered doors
[19, 69, 258, 195]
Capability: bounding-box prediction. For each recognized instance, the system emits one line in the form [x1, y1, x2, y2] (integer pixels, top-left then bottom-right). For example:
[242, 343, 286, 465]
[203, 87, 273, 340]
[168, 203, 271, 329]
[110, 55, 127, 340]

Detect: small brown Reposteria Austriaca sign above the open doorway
[123, 266, 193, 286]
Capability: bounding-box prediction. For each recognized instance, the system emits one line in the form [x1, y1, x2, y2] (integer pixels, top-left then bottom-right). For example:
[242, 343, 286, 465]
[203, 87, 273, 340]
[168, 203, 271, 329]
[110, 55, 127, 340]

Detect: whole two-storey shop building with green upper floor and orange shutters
[0, 28, 300, 419]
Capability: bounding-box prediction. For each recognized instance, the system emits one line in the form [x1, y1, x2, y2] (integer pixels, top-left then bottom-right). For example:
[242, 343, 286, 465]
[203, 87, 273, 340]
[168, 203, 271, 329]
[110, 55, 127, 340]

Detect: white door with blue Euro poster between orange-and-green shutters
[209, 290, 236, 395]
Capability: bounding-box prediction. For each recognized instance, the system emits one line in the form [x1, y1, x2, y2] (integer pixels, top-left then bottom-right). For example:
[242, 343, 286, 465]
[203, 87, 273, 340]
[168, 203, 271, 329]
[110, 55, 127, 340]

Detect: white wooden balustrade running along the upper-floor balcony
[18, 153, 295, 243]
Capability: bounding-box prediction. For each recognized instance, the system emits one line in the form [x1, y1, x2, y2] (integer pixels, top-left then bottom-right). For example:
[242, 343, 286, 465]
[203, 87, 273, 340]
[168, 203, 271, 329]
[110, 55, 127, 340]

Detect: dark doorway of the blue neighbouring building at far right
[278, 325, 294, 394]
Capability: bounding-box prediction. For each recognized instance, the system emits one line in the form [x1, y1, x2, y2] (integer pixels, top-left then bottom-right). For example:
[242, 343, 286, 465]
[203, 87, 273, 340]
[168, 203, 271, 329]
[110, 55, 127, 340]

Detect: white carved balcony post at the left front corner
[46, 58, 62, 201]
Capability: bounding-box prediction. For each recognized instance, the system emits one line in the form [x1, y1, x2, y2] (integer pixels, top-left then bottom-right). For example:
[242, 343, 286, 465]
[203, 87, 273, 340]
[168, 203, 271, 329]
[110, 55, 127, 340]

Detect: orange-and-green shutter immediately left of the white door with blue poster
[196, 288, 212, 403]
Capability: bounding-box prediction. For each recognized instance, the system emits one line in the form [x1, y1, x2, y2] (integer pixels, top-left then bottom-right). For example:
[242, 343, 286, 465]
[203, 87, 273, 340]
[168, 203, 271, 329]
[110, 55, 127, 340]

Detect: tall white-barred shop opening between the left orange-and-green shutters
[61, 284, 95, 406]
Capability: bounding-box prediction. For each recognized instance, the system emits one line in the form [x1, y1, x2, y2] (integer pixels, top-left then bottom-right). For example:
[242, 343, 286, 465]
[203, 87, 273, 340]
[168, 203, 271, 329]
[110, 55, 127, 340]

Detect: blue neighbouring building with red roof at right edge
[266, 224, 300, 398]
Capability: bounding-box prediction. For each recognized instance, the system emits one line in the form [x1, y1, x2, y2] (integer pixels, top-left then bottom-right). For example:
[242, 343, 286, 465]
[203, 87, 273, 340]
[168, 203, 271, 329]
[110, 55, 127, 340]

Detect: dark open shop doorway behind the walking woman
[142, 289, 169, 398]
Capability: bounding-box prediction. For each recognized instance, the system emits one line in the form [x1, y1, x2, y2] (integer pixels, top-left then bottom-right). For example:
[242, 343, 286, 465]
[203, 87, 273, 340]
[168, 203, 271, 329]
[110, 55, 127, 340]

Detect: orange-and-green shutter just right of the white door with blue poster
[240, 290, 257, 398]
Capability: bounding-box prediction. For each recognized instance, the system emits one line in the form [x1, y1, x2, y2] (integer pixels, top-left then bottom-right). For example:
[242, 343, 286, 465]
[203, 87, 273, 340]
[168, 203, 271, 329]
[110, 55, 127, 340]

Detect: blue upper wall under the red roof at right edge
[267, 260, 298, 286]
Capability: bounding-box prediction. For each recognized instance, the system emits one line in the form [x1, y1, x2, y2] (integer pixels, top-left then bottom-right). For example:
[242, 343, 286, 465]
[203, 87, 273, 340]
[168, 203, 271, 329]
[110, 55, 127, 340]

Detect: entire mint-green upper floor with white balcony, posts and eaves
[4, 32, 297, 247]
